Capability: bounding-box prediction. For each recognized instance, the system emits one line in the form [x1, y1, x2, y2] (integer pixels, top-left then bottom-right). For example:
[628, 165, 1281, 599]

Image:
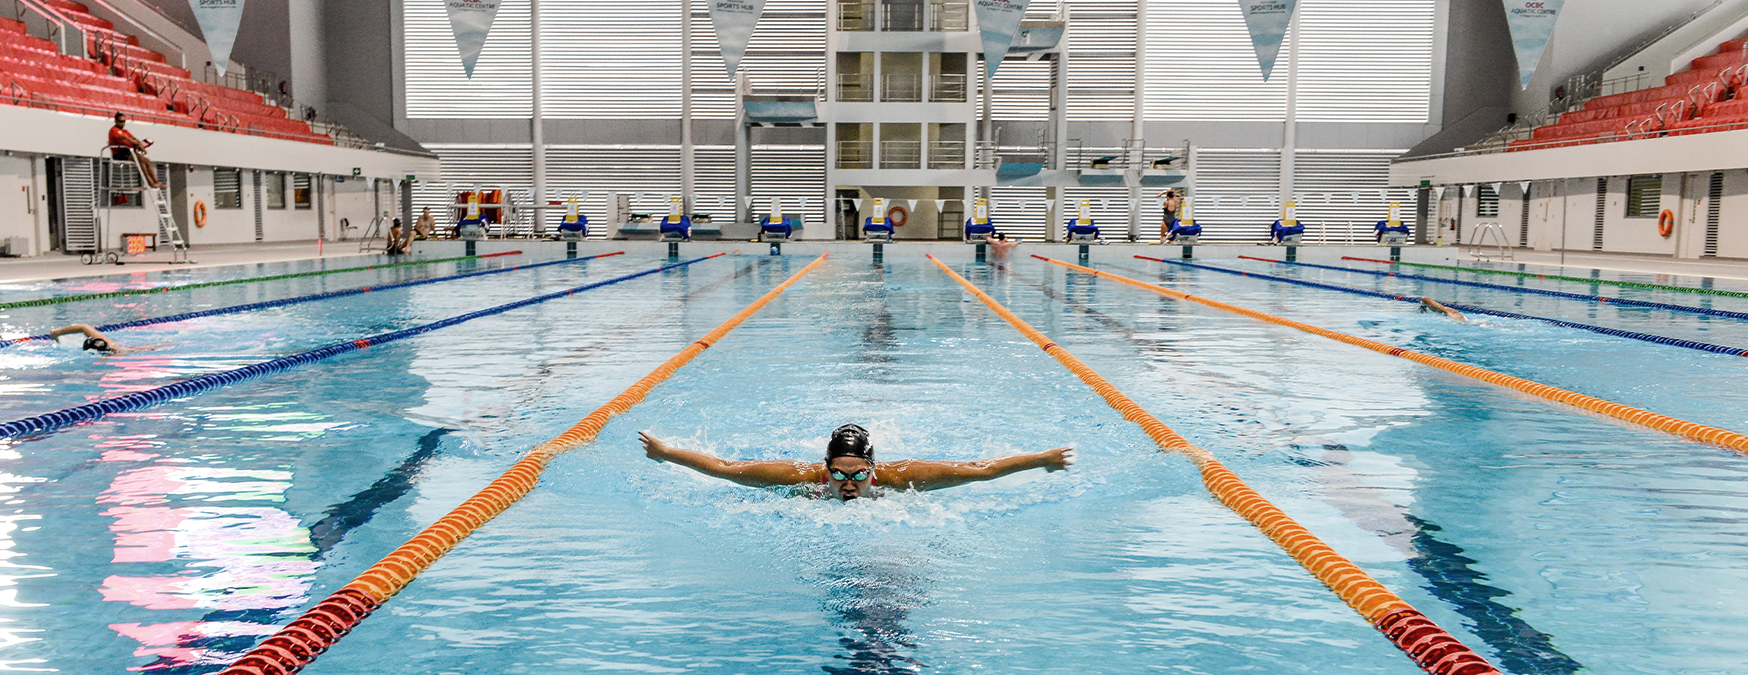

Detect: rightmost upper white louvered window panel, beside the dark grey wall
[1300, 0, 1435, 124]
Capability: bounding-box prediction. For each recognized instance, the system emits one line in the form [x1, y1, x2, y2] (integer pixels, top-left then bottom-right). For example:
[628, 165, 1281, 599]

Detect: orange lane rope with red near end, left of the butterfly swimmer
[209, 254, 829, 675]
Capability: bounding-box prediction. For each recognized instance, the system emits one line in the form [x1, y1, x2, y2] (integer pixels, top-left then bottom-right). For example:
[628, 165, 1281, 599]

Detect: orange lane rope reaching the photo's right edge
[1033, 255, 1748, 453]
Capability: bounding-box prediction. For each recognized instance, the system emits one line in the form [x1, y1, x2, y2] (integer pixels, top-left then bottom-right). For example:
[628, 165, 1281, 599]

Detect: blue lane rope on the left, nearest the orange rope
[0, 254, 727, 439]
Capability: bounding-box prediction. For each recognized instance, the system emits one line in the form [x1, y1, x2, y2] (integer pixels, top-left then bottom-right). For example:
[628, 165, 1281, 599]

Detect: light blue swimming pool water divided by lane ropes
[0, 247, 1748, 673]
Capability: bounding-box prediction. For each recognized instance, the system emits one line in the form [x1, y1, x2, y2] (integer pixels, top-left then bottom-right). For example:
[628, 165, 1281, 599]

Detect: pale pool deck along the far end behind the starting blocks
[0, 240, 1748, 282]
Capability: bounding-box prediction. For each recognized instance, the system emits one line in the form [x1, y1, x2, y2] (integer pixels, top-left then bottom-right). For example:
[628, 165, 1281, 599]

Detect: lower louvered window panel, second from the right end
[1192, 149, 1281, 243]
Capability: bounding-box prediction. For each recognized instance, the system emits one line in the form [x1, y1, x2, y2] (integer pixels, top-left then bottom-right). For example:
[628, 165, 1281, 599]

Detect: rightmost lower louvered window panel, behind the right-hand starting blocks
[1293, 150, 1414, 243]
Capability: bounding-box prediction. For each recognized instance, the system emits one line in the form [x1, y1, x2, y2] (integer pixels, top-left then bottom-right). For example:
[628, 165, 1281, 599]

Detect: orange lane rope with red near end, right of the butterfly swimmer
[928, 255, 1498, 675]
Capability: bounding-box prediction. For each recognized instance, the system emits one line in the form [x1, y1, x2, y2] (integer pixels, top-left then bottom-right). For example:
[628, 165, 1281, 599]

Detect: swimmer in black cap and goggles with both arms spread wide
[640, 425, 1075, 502]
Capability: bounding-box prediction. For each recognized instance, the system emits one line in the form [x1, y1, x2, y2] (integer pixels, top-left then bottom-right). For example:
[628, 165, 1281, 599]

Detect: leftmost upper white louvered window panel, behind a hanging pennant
[402, 0, 527, 119]
